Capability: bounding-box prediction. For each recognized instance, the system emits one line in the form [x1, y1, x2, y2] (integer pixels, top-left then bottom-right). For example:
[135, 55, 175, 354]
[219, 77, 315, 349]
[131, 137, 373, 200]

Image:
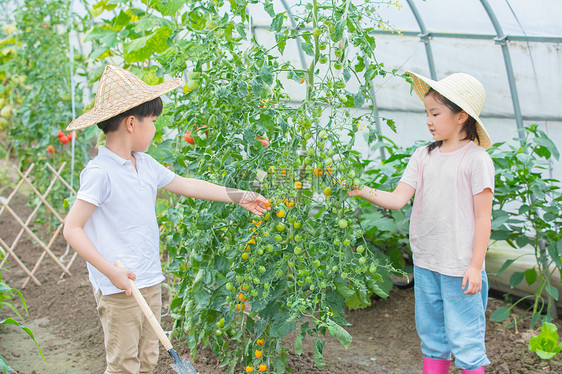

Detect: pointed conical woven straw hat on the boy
[66, 65, 183, 131]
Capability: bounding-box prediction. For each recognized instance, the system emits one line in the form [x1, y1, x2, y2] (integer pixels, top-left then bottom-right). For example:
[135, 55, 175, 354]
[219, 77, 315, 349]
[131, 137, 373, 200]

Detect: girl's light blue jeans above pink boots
[414, 265, 490, 370]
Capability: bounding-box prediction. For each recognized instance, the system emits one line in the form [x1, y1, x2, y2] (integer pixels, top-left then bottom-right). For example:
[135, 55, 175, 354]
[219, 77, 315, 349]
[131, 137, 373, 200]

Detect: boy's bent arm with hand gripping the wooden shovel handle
[63, 199, 135, 296]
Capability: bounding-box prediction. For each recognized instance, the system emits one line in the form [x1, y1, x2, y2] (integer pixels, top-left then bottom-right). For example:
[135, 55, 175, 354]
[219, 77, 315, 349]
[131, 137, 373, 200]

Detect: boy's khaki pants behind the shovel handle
[95, 284, 162, 374]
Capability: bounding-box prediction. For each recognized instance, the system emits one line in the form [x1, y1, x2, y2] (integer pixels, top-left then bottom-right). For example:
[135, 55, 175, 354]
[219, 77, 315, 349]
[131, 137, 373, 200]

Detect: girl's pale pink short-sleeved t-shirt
[400, 142, 495, 277]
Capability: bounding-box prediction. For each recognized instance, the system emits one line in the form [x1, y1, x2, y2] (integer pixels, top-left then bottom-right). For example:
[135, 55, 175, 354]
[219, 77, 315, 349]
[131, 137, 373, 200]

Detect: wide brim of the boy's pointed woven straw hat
[66, 78, 183, 131]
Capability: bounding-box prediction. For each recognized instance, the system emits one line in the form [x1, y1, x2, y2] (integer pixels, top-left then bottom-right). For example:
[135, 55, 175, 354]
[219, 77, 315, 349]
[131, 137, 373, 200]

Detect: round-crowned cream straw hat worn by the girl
[406, 71, 492, 149]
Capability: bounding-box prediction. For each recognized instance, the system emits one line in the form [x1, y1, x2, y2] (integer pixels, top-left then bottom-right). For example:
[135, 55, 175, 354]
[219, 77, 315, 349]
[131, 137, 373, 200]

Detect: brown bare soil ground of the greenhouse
[0, 192, 562, 374]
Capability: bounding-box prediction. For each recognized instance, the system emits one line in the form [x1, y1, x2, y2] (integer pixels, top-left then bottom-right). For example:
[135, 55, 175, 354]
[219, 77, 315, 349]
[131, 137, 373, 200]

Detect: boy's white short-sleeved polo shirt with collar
[76, 146, 175, 295]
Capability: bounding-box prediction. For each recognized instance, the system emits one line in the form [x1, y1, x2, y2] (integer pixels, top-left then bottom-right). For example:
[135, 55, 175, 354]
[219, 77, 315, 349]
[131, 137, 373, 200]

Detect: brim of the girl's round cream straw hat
[406, 71, 492, 149]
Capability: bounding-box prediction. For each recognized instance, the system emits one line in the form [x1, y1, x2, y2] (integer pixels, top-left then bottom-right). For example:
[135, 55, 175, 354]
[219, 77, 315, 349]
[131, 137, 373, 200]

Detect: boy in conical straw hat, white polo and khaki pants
[64, 65, 270, 374]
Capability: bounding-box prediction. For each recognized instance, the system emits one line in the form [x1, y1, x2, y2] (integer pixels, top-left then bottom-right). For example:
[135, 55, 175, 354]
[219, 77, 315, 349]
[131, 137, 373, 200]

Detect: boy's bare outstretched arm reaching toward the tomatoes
[163, 175, 271, 215]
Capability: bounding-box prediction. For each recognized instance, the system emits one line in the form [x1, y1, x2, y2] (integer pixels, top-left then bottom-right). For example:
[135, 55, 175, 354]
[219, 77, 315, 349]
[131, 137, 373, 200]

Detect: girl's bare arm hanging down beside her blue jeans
[462, 188, 493, 295]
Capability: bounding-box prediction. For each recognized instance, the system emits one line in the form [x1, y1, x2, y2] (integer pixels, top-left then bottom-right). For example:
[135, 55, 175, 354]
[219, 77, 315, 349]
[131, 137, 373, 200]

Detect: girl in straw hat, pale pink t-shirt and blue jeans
[351, 72, 494, 374]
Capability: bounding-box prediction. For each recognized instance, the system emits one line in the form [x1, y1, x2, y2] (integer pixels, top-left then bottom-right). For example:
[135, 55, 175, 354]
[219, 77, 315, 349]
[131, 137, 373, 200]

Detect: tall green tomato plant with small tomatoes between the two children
[77, 0, 406, 372]
